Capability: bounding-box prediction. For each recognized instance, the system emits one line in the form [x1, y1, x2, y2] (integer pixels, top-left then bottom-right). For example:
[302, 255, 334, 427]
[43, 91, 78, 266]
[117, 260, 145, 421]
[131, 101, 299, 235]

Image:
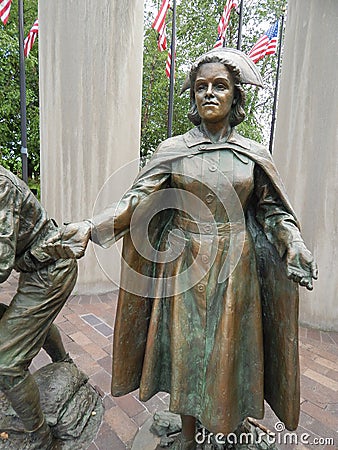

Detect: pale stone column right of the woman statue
[274, 0, 338, 330]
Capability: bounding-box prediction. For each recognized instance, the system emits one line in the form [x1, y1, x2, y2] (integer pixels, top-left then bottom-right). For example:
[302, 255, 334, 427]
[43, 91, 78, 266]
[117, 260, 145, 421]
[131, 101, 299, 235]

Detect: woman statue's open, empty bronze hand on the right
[286, 241, 318, 291]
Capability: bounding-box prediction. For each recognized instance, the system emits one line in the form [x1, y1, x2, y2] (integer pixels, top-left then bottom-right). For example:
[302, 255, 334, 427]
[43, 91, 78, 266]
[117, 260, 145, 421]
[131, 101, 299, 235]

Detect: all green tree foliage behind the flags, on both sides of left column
[0, 0, 287, 179]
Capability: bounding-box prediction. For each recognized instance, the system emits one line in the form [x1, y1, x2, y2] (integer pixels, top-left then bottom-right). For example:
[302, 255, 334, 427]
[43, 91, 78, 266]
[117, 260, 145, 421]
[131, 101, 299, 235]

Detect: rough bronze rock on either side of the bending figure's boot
[0, 362, 103, 450]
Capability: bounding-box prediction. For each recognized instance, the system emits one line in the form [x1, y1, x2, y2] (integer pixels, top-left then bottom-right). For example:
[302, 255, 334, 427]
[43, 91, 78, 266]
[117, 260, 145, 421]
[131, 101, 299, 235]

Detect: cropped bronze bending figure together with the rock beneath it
[0, 166, 103, 450]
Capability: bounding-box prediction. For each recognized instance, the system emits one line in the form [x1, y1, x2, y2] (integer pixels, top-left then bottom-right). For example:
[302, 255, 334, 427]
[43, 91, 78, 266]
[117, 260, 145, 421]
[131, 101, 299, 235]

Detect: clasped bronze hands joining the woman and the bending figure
[41, 220, 91, 259]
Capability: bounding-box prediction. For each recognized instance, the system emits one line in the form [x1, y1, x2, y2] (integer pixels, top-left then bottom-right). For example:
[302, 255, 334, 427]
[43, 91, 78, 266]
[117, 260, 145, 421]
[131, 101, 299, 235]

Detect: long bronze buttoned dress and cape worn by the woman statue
[94, 128, 301, 433]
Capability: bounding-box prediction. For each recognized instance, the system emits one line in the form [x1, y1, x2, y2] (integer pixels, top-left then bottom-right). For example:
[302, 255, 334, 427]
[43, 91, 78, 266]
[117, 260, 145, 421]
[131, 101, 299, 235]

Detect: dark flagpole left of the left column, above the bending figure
[18, 0, 28, 184]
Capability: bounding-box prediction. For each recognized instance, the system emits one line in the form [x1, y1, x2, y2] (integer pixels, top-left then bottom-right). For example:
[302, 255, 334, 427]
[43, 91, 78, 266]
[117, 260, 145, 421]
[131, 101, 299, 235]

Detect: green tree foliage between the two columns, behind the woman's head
[141, 0, 287, 161]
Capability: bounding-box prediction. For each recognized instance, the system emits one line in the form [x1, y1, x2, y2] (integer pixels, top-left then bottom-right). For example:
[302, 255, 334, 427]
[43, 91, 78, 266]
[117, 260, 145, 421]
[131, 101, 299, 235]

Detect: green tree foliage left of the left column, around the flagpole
[0, 0, 40, 178]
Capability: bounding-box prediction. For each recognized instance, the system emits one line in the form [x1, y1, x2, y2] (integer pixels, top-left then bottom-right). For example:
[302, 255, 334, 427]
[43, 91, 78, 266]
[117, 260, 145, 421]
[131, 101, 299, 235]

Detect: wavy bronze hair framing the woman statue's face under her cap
[188, 55, 245, 127]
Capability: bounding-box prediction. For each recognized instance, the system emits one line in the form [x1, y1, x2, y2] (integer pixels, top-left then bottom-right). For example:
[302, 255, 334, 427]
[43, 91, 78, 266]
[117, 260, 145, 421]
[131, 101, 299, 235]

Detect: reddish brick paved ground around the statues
[0, 275, 338, 450]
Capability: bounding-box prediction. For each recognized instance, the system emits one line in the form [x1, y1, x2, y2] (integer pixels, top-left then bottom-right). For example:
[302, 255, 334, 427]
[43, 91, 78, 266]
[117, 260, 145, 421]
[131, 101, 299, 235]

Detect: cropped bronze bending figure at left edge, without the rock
[0, 166, 77, 450]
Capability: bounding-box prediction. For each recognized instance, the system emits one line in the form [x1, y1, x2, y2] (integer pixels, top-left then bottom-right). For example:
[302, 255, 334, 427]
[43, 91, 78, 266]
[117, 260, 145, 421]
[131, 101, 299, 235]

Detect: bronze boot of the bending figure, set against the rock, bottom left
[3, 373, 60, 450]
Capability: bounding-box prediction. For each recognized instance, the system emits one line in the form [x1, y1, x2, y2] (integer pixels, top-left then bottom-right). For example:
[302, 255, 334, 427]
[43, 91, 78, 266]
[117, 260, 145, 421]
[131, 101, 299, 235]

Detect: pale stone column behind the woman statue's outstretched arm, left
[39, 0, 143, 293]
